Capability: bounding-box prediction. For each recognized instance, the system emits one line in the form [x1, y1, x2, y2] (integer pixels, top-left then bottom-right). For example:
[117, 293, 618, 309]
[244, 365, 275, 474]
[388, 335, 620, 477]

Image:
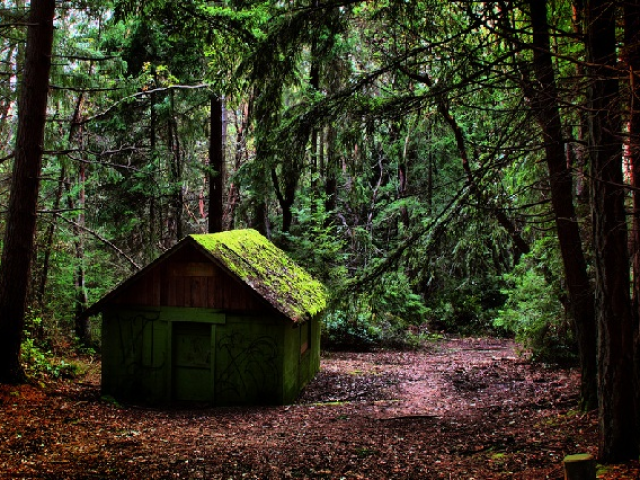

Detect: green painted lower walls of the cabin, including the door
[102, 308, 320, 405]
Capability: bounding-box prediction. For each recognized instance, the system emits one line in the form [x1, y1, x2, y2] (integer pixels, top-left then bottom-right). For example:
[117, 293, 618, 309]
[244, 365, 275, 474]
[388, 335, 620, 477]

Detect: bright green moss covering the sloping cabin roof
[190, 230, 327, 322]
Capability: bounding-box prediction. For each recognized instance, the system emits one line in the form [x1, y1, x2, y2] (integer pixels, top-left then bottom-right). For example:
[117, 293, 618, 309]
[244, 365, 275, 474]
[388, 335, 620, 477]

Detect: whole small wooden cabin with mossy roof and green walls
[87, 230, 326, 405]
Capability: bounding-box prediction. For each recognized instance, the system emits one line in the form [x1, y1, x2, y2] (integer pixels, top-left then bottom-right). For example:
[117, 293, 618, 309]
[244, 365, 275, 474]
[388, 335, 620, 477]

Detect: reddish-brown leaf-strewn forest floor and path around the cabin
[0, 339, 640, 480]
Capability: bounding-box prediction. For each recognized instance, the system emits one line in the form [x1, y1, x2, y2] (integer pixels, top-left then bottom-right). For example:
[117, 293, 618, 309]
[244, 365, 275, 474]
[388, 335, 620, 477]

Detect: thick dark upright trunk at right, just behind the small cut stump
[585, 0, 638, 462]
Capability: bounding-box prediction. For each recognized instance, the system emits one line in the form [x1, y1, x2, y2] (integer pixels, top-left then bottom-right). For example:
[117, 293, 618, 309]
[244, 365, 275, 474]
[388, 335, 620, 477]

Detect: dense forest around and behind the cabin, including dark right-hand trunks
[0, 0, 640, 461]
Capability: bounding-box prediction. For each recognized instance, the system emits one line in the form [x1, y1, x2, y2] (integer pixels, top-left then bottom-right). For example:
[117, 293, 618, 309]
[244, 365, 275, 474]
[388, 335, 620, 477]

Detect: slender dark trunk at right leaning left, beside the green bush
[526, 0, 598, 410]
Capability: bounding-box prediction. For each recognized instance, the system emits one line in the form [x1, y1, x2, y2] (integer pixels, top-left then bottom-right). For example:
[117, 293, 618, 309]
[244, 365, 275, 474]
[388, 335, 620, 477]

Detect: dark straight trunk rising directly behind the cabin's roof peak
[208, 95, 225, 233]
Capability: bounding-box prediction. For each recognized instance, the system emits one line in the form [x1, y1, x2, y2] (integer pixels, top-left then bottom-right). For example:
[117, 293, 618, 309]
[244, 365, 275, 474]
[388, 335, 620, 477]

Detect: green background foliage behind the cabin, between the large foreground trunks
[0, 0, 580, 372]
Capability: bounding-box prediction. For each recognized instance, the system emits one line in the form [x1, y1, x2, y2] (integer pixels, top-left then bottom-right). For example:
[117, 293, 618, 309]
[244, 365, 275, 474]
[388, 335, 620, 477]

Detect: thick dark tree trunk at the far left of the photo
[0, 0, 55, 383]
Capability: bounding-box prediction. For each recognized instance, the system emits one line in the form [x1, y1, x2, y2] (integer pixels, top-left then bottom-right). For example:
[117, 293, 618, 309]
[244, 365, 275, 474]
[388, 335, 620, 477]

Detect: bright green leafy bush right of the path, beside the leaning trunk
[494, 236, 576, 363]
